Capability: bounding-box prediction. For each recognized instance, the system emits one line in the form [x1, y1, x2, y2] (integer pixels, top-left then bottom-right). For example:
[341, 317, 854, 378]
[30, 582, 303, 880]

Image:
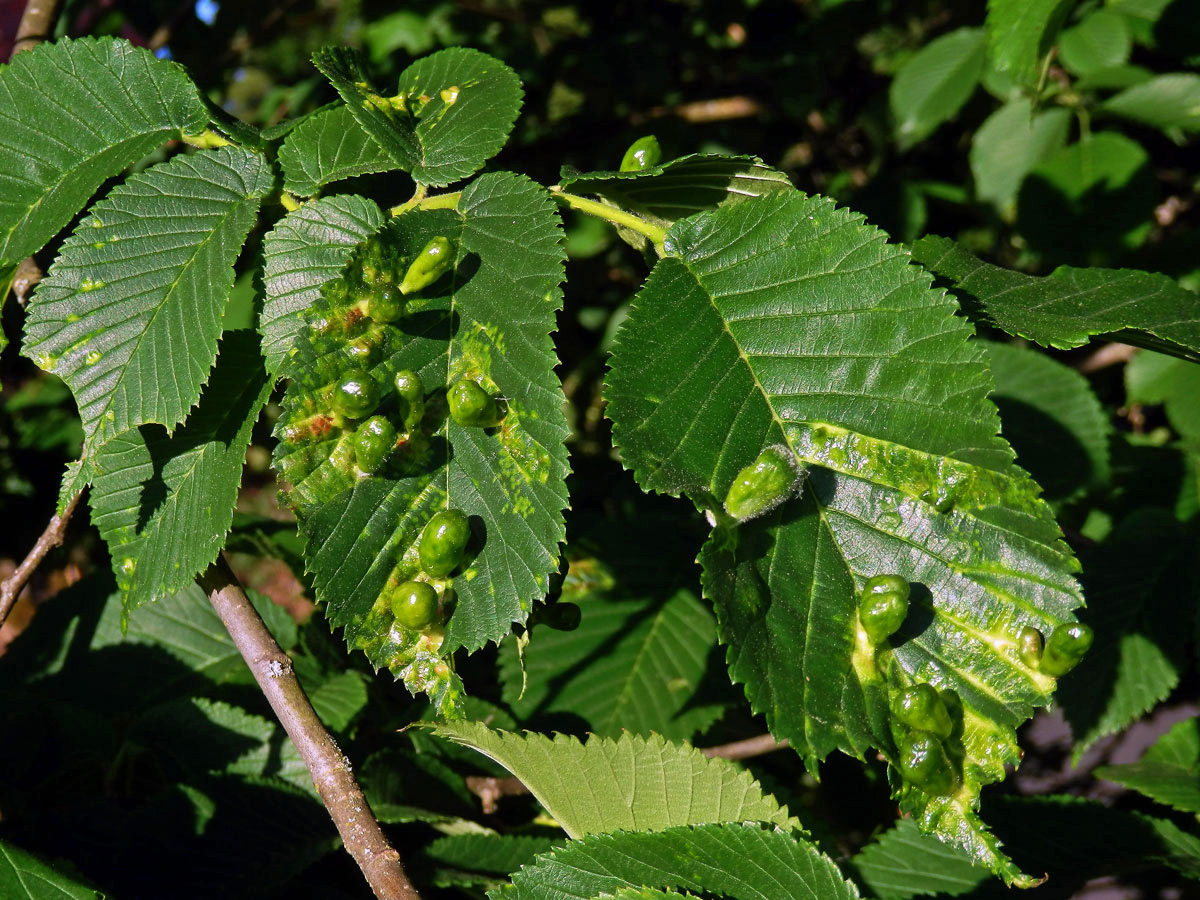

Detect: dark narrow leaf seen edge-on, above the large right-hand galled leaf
[559, 154, 794, 246]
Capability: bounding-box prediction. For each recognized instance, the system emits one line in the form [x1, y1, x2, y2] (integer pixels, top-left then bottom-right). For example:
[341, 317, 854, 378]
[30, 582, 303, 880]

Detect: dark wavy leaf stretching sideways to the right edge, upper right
[912, 235, 1200, 361]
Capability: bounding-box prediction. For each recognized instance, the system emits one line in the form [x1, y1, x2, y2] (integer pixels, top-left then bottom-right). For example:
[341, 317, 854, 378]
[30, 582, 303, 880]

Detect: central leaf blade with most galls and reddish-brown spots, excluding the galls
[275, 173, 568, 714]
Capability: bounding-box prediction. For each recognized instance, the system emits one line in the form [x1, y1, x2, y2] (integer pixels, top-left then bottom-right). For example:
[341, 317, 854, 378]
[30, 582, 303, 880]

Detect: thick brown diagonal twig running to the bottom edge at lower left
[197, 554, 420, 900]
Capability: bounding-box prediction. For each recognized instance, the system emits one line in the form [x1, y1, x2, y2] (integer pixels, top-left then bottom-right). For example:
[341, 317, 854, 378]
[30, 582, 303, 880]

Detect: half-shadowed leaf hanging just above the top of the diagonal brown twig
[89, 331, 270, 610]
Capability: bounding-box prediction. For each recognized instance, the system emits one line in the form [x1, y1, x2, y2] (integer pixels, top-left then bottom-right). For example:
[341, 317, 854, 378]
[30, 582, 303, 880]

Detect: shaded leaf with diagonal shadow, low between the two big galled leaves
[500, 540, 722, 740]
